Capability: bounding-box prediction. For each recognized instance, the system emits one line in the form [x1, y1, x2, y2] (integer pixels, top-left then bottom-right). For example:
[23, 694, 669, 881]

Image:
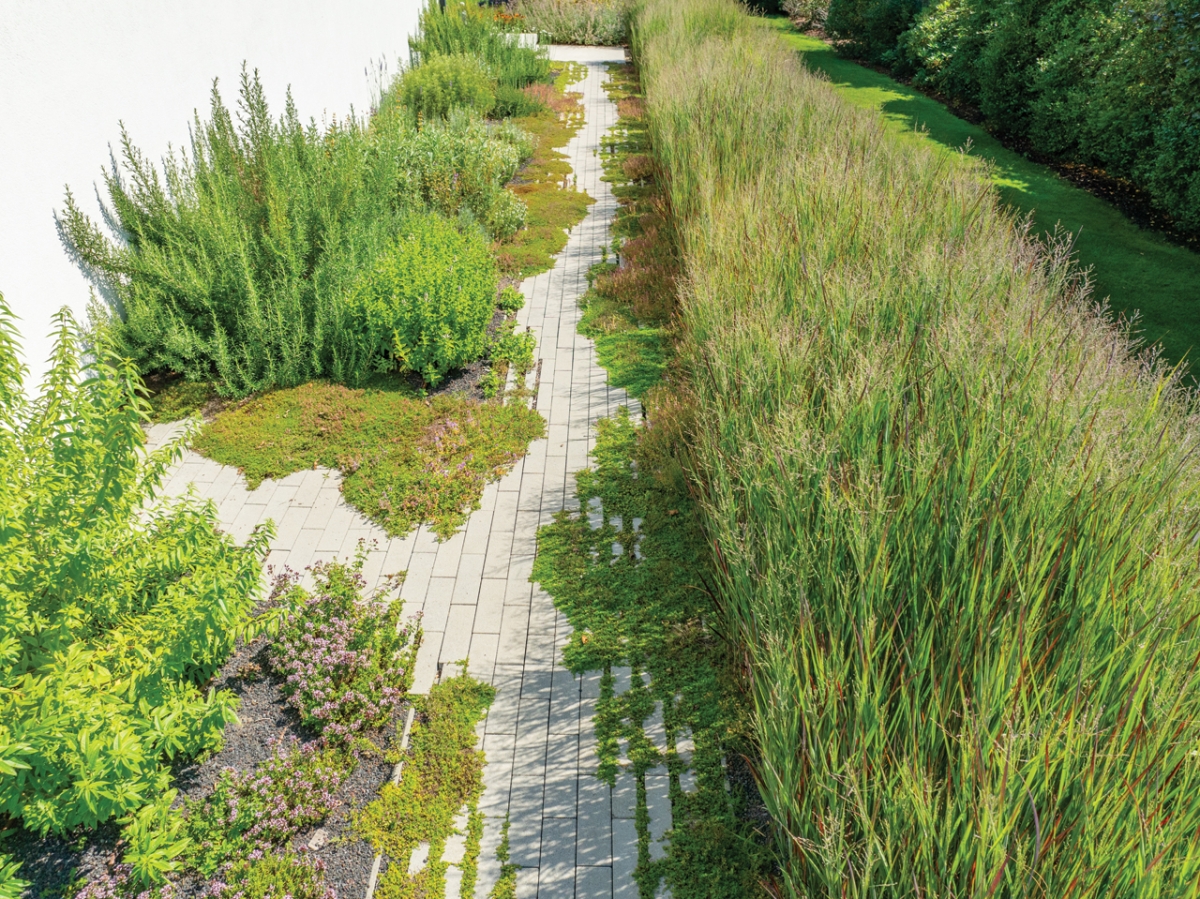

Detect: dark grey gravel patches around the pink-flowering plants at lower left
[4, 636, 396, 899]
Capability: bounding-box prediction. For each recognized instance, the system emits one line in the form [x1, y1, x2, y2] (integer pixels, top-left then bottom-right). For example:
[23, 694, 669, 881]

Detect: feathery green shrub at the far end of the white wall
[408, 0, 550, 88]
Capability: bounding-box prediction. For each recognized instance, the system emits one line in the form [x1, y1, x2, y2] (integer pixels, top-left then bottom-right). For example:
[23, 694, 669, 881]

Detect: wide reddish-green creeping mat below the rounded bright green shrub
[196, 382, 545, 537]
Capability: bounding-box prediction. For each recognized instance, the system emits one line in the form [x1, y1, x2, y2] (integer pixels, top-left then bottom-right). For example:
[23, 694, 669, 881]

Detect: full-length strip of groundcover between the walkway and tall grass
[533, 59, 770, 899]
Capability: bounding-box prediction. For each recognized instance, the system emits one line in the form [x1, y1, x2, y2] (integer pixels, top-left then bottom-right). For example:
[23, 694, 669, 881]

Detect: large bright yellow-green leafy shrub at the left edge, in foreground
[0, 300, 270, 833]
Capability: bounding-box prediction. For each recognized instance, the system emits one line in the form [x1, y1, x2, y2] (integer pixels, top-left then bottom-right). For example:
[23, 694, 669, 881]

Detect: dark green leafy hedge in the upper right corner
[826, 0, 1200, 230]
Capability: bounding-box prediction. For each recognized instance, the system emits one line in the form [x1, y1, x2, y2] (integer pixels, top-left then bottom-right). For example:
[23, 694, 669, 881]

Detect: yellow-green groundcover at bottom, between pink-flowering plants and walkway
[354, 675, 496, 899]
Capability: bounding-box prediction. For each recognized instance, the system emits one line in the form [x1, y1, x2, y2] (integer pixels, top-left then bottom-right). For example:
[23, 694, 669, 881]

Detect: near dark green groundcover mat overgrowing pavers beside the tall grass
[533, 407, 769, 899]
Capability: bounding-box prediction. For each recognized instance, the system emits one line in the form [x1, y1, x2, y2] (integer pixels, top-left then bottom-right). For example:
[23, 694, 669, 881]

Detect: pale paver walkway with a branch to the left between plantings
[151, 47, 638, 899]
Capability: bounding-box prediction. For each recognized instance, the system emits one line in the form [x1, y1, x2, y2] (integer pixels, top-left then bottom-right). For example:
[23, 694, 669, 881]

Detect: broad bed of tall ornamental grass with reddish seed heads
[632, 0, 1200, 899]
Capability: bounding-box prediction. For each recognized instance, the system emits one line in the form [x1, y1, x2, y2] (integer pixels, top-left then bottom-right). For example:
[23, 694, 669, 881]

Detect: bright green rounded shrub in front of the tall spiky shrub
[346, 215, 499, 384]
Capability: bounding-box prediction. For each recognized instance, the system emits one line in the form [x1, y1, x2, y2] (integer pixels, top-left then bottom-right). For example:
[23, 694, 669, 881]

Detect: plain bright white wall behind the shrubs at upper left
[0, 0, 421, 389]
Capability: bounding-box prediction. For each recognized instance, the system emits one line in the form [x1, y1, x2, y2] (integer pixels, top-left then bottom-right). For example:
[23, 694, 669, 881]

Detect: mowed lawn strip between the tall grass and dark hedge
[769, 19, 1200, 376]
